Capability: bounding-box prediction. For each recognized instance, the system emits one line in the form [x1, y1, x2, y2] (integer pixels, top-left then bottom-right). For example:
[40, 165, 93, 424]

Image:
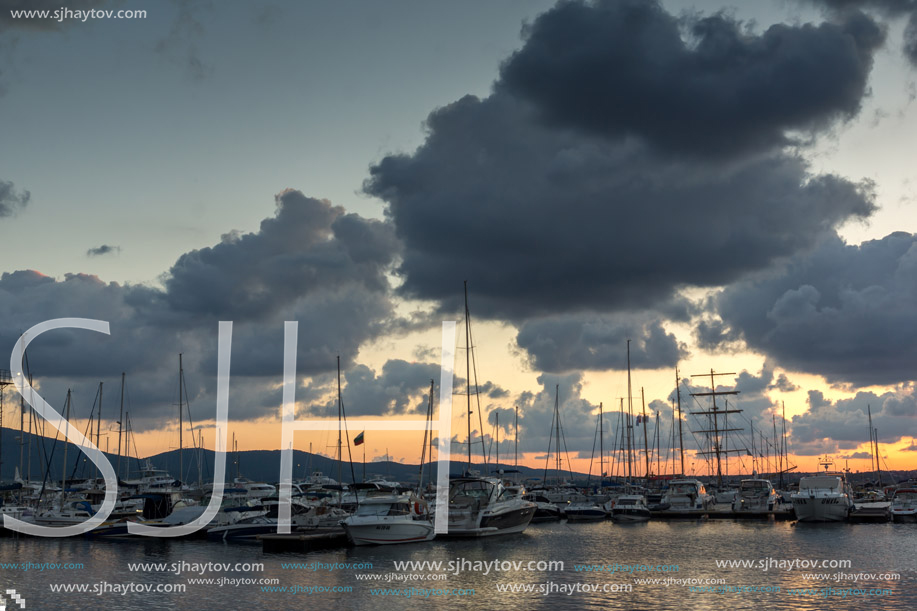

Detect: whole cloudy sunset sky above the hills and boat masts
[0, 0, 917, 482]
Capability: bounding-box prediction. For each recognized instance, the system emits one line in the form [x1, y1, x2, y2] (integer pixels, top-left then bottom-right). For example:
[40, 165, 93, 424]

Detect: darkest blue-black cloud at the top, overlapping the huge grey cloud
[496, 0, 884, 156]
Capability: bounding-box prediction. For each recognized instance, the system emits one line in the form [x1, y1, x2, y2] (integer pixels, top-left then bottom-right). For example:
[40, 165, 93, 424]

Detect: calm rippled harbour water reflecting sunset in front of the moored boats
[0, 521, 917, 611]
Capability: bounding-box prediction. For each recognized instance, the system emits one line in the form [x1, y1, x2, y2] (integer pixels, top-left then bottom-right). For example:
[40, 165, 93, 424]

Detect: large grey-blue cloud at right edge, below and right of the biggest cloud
[698, 233, 917, 386]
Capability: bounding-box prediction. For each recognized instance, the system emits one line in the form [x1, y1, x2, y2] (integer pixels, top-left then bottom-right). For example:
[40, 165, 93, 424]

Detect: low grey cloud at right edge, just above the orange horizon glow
[790, 385, 917, 455]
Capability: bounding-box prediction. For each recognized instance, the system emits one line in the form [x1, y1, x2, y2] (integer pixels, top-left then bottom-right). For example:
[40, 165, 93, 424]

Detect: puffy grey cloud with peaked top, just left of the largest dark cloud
[164, 190, 395, 320]
